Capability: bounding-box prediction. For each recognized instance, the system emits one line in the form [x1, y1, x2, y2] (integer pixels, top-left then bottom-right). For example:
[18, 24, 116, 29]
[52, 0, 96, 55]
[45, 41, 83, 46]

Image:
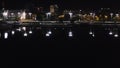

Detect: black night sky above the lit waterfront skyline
[0, 0, 120, 9]
